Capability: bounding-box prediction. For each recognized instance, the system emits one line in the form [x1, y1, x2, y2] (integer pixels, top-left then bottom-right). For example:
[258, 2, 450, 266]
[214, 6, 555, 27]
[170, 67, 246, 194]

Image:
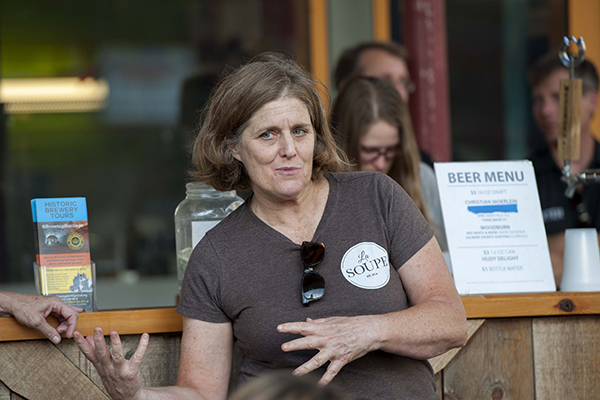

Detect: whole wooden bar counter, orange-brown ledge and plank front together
[0, 292, 600, 400]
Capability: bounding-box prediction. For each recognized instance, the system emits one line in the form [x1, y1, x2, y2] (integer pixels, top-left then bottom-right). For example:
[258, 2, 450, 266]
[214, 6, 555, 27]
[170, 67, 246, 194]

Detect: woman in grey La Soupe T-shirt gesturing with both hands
[75, 54, 466, 400]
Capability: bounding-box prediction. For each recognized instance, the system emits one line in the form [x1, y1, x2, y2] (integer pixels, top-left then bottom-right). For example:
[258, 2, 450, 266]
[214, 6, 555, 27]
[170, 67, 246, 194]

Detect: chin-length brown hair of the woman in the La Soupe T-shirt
[190, 53, 349, 191]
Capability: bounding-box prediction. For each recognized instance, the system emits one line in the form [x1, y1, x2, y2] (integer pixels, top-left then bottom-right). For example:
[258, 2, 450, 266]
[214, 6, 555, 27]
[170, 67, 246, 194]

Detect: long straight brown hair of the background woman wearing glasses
[331, 77, 431, 222]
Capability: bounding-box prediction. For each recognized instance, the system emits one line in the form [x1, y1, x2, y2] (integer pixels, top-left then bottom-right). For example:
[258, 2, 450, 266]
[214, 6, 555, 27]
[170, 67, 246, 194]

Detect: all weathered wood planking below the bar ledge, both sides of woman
[0, 315, 600, 400]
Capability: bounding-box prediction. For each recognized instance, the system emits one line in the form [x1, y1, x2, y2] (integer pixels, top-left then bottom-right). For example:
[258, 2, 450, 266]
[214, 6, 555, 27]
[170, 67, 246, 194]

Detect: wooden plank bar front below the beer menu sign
[436, 315, 600, 400]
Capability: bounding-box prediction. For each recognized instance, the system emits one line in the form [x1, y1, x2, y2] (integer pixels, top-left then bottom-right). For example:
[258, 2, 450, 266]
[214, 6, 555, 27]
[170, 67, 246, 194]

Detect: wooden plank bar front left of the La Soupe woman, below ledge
[0, 333, 181, 400]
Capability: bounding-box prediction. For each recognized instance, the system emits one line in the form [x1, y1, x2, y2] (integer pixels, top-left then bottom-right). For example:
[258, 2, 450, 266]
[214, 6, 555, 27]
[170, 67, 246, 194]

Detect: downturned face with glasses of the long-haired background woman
[359, 121, 400, 174]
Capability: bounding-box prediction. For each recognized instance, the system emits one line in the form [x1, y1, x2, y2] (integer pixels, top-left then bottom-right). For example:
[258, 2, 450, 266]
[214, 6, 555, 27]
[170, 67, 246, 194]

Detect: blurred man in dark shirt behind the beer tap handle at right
[528, 52, 600, 286]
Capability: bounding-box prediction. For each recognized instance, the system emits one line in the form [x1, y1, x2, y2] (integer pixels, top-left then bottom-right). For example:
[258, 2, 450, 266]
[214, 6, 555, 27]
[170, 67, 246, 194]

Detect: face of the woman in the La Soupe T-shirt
[230, 97, 315, 200]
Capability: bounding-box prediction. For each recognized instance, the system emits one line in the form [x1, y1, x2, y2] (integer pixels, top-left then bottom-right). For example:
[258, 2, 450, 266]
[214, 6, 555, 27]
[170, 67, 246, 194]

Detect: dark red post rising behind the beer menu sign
[404, 0, 452, 161]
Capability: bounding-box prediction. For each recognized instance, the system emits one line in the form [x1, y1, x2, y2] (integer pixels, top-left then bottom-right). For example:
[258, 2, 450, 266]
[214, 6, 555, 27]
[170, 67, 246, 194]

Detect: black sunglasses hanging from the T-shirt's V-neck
[301, 242, 325, 306]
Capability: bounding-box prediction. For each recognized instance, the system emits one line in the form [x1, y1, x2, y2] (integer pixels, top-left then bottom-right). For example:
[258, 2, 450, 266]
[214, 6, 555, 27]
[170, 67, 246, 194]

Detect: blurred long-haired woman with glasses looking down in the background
[331, 77, 448, 250]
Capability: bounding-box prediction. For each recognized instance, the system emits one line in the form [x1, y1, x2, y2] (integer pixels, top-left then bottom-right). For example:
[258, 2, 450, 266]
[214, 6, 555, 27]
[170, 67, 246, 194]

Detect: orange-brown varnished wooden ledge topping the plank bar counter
[0, 292, 600, 342]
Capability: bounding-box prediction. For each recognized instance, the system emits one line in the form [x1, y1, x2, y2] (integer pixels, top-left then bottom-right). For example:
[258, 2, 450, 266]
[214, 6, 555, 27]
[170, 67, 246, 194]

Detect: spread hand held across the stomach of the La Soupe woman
[277, 316, 377, 385]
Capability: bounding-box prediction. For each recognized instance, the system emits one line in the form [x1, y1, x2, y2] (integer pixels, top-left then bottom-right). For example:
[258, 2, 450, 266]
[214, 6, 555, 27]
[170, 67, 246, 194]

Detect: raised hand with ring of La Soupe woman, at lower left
[74, 328, 150, 400]
